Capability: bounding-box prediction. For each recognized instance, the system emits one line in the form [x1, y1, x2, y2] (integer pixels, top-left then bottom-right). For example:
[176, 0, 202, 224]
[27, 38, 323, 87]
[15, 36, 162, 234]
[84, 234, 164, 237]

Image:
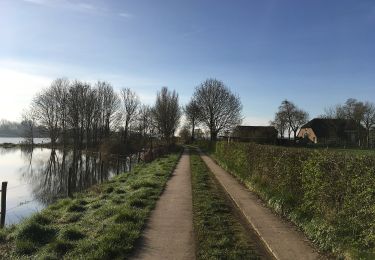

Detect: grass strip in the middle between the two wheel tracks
[190, 149, 259, 259]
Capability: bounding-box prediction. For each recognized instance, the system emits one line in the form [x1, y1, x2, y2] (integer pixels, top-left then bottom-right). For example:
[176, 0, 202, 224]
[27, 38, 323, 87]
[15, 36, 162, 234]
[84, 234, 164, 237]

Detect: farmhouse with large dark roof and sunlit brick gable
[298, 118, 366, 146]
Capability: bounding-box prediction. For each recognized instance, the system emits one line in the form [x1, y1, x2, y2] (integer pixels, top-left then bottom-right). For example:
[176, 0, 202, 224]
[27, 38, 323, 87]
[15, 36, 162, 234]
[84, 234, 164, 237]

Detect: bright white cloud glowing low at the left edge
[0, 68, 52, 121]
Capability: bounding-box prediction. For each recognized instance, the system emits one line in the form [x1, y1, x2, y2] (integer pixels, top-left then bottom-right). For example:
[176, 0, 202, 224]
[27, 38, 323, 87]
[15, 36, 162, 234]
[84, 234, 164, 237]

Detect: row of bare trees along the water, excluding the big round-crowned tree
[24, 78, 181, 153]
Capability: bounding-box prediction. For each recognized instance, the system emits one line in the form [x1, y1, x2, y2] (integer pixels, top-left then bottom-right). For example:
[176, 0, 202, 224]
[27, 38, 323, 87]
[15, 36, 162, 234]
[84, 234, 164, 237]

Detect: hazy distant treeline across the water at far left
[0, 119, 48, 137]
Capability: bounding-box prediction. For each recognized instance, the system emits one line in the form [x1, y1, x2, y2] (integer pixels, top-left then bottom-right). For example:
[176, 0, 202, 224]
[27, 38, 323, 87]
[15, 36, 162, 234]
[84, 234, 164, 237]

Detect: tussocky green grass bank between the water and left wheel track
[0, 150, 179, 259]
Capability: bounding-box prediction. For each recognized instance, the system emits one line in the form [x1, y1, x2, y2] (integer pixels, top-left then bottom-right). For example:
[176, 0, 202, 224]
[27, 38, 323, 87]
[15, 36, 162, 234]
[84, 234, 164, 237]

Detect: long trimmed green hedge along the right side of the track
[199, 142, 375, 259]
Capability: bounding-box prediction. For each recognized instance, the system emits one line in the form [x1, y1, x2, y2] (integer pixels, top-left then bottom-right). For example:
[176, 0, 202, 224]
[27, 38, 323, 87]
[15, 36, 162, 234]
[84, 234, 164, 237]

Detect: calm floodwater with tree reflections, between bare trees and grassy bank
[0, 148, 136, 225]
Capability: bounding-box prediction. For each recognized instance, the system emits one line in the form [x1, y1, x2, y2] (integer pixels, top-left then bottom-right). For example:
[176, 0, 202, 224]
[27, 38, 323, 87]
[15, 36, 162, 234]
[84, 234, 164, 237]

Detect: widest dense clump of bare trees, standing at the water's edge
[27, 78, 120, 148]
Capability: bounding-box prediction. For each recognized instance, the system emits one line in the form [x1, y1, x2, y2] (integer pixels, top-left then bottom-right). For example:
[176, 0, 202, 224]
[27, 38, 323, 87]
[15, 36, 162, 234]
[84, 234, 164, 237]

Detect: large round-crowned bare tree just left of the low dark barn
[193, 79, 242, 141]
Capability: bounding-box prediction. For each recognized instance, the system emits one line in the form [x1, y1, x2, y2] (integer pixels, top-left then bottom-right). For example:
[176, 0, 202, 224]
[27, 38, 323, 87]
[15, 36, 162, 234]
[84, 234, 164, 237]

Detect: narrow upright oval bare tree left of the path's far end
[152, 87, 181, 143]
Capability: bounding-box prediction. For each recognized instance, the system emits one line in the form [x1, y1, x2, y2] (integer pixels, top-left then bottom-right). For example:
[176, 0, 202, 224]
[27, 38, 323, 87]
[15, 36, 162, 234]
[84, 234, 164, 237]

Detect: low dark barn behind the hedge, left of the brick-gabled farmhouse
[231, 125, 277, 144]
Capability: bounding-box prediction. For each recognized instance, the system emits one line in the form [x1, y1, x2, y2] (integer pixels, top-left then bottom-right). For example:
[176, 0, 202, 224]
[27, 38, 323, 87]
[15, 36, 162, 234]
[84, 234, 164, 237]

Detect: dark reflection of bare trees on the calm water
[20, 149, 136, 206]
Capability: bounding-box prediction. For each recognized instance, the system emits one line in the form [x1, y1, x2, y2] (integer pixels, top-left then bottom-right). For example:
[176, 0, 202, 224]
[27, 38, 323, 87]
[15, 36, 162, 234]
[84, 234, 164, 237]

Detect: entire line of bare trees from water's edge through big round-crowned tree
[23, 78, 242, 149]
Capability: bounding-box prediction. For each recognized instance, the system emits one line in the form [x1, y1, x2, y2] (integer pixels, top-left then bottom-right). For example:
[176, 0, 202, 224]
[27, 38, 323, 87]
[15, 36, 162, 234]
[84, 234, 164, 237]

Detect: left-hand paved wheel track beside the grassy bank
[133, 150, 195, 260]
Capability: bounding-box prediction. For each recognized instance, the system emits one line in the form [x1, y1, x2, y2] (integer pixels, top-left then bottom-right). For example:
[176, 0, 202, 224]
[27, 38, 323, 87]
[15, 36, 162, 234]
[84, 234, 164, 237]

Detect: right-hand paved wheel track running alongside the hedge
[201, 154, 324, 260]
